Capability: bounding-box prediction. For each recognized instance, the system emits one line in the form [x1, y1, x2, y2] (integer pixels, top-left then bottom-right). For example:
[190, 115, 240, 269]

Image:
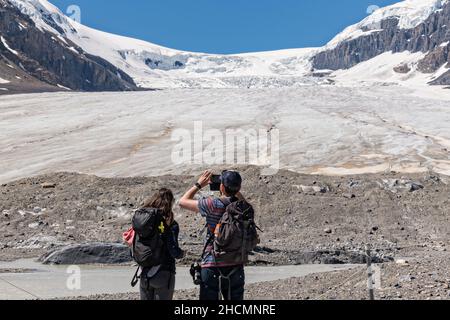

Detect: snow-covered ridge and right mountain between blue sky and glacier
[0, 0, 450, 90]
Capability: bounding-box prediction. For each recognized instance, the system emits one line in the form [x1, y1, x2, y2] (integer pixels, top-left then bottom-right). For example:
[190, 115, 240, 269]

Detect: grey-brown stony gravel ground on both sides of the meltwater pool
[0, 167, 450, 299]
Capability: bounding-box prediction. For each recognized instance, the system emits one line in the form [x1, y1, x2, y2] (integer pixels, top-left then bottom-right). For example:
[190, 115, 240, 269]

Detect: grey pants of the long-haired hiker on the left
[140, 271, 175, 300]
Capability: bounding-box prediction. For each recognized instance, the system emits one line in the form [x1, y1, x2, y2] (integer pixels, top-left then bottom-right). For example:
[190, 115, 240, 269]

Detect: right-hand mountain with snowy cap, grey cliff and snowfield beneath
[312, 0, 450, 85]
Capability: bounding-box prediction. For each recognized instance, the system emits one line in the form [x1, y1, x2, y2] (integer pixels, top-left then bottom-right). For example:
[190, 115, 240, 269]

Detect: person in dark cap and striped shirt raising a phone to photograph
[179, 171, 259, 301]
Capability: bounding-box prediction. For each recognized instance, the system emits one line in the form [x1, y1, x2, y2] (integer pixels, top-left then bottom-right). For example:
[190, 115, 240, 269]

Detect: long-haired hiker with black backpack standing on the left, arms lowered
[127, 188, 184, 300]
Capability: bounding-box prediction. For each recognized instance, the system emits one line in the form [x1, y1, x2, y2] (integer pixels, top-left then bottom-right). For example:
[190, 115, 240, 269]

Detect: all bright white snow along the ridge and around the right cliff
[10, 0, 447, 88]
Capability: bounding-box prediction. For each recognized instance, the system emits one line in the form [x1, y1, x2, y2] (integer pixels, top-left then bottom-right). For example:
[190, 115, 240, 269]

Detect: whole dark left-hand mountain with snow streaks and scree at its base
[0, 0, 137, 93]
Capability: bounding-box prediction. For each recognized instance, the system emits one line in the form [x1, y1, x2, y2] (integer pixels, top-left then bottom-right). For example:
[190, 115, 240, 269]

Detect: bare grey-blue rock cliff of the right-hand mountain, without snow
[313, 2, 450, 84]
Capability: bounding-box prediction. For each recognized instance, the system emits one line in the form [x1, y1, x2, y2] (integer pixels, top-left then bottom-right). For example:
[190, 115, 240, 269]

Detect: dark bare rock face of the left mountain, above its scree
[0, 0, 137, 91]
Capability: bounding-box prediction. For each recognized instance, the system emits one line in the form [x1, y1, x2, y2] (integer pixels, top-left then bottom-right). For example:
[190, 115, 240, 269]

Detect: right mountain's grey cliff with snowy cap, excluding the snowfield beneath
[313, 0, 450, 85]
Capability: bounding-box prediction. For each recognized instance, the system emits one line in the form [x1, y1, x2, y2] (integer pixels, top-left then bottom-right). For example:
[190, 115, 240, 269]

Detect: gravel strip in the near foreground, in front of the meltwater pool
[65, 254, 450, 300]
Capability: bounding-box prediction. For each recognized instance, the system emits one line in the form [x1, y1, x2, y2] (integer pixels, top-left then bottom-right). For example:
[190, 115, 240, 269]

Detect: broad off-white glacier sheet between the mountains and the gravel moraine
[0, 84, 450, 182]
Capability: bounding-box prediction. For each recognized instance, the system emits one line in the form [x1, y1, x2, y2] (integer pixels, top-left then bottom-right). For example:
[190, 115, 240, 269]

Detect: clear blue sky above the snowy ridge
[50, 0, 398, 53]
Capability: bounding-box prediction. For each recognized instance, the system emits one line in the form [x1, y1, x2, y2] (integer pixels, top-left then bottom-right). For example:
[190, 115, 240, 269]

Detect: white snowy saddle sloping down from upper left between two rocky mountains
[3, 0, 322, 88]
